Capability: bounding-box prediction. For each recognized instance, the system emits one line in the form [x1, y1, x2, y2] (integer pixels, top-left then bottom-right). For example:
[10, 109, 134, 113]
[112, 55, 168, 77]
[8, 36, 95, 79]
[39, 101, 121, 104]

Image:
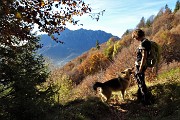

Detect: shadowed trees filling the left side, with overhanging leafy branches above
[0, 0, 101, 120]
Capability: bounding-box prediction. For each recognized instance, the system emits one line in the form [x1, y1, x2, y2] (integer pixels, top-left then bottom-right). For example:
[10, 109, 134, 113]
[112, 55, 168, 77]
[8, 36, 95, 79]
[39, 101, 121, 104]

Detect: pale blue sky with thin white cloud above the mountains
[67, 0, 177, 37]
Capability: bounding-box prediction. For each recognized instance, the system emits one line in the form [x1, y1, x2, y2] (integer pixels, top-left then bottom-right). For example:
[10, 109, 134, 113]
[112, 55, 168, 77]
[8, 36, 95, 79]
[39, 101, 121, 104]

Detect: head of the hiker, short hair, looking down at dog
[132, 29, 145, 41]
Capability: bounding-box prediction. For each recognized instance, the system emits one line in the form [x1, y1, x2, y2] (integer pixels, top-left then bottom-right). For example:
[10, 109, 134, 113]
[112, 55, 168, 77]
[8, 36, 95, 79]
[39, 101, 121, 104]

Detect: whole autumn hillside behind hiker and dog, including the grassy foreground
[50, 7, 180, 120]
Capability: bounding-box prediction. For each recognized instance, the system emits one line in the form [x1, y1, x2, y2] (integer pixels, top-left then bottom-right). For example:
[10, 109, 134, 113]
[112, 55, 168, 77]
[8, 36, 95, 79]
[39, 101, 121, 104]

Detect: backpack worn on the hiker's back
[146, 40, 160, 67]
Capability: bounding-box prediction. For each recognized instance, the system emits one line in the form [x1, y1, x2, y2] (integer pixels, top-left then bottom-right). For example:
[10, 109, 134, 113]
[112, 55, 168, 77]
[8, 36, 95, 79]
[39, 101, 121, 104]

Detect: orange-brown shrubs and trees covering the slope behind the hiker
[49, 6, 180, 100]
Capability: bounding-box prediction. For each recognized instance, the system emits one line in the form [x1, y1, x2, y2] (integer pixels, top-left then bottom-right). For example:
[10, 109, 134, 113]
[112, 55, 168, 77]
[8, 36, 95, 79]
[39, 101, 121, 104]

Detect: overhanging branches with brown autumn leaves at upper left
[0, 0, 99, 45]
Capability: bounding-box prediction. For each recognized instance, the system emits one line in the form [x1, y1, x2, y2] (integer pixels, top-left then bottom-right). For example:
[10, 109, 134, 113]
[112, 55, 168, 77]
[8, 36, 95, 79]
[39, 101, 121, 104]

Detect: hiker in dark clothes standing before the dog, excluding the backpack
[132, 29, 151, 105]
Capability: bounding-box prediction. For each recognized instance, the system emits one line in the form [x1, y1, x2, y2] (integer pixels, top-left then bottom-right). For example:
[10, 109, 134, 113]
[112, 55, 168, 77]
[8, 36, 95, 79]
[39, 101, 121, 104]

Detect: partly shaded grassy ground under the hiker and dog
[52, 68, 180, 120]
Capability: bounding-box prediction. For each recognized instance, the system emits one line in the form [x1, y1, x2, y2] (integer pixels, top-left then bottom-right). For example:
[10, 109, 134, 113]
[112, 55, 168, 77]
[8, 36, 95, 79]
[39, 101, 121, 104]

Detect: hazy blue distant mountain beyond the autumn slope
[39, 29, 117, 66]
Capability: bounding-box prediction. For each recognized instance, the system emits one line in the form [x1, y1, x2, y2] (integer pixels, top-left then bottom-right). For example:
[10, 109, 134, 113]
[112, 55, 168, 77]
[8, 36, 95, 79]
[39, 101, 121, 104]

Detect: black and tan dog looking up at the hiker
[93, 68, 134, 102]
